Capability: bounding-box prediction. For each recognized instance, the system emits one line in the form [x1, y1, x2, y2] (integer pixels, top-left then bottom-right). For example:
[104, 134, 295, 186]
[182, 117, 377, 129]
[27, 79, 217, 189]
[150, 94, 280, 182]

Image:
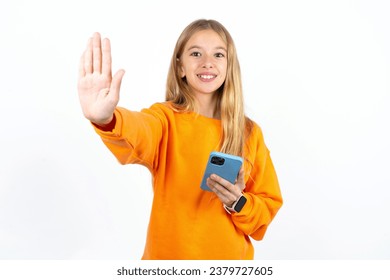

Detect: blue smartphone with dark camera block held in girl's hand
[200, 152, 242, 191]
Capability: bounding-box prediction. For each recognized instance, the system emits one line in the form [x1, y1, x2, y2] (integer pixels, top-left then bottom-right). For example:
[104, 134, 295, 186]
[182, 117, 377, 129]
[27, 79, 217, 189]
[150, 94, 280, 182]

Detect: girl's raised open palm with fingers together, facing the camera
[78, 33, 125, 125]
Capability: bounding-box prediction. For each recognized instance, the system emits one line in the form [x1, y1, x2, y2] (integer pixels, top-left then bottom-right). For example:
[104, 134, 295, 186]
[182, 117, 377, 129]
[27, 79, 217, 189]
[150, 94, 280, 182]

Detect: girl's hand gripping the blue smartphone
[207, 168, 245, 207]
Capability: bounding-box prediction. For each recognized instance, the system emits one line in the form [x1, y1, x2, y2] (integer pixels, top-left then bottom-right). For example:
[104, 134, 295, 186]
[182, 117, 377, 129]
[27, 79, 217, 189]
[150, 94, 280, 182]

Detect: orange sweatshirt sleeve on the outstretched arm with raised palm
[94, 106, 165, 170]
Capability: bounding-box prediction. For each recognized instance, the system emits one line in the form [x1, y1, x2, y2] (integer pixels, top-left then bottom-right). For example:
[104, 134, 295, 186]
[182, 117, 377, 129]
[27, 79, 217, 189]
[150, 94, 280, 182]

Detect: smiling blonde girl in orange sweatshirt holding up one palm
[78, 20, 282, 259]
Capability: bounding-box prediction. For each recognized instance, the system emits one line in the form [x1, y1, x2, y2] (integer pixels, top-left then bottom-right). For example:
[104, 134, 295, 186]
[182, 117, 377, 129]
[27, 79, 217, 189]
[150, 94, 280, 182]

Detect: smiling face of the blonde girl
[181, 30, 227, 96]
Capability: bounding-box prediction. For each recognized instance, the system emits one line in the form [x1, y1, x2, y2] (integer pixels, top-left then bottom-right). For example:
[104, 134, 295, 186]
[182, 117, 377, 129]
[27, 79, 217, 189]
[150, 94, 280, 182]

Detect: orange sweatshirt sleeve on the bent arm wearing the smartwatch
[232, 126, 283, 240]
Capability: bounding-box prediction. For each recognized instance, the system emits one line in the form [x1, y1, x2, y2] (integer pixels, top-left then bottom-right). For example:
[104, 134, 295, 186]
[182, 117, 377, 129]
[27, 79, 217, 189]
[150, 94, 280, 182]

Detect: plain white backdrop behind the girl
[0, 0, 390, 259]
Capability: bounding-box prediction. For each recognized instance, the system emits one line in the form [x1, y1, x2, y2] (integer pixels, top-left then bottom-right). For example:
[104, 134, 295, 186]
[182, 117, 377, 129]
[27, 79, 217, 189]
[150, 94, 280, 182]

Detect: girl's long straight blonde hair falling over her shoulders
[165, 19, 253, 156]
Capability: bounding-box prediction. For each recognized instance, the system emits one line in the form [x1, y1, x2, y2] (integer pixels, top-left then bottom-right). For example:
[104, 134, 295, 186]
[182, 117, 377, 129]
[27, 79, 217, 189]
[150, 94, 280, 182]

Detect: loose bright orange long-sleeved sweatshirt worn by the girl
[95, 103, 282, 260]
